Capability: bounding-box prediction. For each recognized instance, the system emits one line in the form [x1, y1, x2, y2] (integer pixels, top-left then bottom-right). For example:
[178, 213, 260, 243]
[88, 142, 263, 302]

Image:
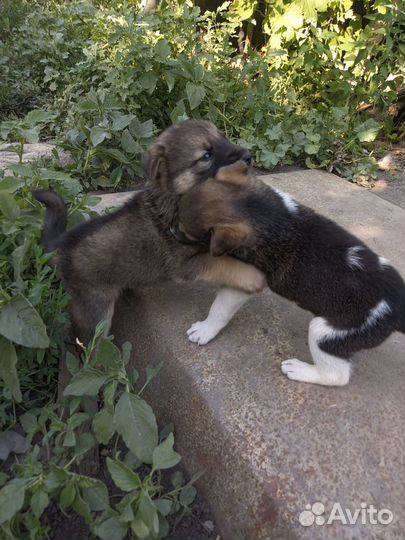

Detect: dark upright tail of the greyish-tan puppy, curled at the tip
[32, 189, 67, 252]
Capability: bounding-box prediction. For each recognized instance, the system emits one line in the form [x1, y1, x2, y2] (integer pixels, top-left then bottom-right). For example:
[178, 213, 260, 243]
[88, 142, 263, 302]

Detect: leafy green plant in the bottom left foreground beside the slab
[0, 323, 198, 540]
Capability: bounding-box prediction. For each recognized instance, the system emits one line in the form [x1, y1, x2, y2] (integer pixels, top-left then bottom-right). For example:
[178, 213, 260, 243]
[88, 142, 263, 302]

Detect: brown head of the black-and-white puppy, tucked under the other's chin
[179, 160, 254, 257]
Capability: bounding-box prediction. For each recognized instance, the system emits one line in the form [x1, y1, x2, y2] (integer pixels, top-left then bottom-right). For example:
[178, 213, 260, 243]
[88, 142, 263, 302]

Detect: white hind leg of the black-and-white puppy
[281, 317, 351, 386]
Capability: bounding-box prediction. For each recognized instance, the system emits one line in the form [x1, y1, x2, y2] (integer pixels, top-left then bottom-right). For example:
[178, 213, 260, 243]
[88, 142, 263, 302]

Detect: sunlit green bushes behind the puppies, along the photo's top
[0, 0, 405, 188]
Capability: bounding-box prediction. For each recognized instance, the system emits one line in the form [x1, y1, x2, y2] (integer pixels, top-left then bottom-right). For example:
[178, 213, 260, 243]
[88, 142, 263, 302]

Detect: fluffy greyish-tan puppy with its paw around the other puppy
[34, 120, 265, 343]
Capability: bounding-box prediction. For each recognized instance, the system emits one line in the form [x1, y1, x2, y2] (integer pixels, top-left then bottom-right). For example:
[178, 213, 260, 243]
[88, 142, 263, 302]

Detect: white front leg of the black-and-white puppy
[187, 288, 252, 345]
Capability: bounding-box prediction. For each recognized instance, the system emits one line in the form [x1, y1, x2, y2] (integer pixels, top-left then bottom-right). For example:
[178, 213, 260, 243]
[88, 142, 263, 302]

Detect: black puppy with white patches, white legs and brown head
[178, 161, 405, 386]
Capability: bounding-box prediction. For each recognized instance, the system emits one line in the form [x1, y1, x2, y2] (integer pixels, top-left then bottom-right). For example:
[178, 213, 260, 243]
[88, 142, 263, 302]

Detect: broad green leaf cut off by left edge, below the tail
[0, 294, 49, 349]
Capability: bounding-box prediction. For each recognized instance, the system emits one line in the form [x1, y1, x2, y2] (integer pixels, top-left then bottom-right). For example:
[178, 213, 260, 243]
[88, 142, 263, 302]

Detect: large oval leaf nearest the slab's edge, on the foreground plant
[114, 392, 158, 463]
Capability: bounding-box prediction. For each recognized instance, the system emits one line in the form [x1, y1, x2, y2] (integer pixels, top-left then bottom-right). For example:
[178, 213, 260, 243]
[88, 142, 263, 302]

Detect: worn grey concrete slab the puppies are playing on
[109, 171, 405, 540]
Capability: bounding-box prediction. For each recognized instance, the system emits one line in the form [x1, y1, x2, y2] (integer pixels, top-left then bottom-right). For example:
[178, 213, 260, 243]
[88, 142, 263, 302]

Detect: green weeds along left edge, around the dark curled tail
[0, 111, 95, 425]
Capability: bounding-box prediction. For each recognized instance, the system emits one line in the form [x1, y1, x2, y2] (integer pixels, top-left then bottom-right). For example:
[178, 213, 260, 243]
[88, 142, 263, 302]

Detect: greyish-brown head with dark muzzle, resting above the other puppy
[146, 120, 252, 194]
